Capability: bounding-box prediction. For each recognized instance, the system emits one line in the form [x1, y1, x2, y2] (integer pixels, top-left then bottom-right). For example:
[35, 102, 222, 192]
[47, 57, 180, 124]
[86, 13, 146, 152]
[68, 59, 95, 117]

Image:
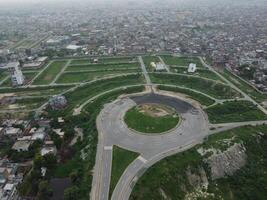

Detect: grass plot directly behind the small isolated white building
[160, 55, 204, 68]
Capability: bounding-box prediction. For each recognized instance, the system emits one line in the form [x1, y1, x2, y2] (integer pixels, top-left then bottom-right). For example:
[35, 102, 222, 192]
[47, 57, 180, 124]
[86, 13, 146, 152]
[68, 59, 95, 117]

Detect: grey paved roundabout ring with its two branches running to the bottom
[91, 91, 209, 200]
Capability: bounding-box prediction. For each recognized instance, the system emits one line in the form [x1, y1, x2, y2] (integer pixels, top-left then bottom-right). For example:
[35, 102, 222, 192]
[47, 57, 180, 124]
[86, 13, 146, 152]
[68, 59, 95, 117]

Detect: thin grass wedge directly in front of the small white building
[170, 66, 224, 83]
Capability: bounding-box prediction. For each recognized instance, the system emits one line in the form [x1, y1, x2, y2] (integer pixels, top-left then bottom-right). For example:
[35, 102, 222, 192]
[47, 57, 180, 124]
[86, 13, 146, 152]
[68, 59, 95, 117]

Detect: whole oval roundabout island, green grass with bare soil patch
[124, 103, 179, 134]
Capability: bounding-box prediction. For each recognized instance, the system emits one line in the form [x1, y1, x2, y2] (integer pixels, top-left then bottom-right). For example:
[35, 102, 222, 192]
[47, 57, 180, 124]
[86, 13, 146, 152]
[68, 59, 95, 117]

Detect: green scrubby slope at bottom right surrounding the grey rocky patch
[130, 125, 267, 200]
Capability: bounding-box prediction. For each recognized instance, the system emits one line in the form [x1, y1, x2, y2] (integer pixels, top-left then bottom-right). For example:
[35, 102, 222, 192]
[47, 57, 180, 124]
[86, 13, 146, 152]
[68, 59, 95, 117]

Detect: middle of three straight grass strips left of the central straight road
[66, 63, 140, 71]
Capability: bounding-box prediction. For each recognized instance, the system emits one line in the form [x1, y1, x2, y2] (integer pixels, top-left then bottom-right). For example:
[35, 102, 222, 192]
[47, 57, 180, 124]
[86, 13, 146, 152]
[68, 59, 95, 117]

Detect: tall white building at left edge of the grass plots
[6, 62, 25, 86]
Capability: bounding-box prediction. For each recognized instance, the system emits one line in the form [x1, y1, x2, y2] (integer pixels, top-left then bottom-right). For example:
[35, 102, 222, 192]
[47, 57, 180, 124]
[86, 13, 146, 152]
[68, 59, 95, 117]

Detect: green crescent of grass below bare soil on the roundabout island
[124, 104, 179, 134]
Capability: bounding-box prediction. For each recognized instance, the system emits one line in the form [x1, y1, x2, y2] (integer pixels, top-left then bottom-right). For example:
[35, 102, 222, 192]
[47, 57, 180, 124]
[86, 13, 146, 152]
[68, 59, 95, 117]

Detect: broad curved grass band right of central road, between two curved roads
[150, 73, 241, 99]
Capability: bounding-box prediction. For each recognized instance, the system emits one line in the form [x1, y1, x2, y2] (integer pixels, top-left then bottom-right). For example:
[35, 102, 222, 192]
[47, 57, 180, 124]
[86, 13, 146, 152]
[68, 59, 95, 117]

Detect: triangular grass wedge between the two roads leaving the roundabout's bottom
[109, 146, 139, 197]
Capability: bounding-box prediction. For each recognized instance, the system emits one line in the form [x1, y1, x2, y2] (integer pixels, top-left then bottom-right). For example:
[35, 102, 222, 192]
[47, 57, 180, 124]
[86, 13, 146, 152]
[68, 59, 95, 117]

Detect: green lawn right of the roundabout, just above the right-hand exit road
[206, 101, 267, 123]
